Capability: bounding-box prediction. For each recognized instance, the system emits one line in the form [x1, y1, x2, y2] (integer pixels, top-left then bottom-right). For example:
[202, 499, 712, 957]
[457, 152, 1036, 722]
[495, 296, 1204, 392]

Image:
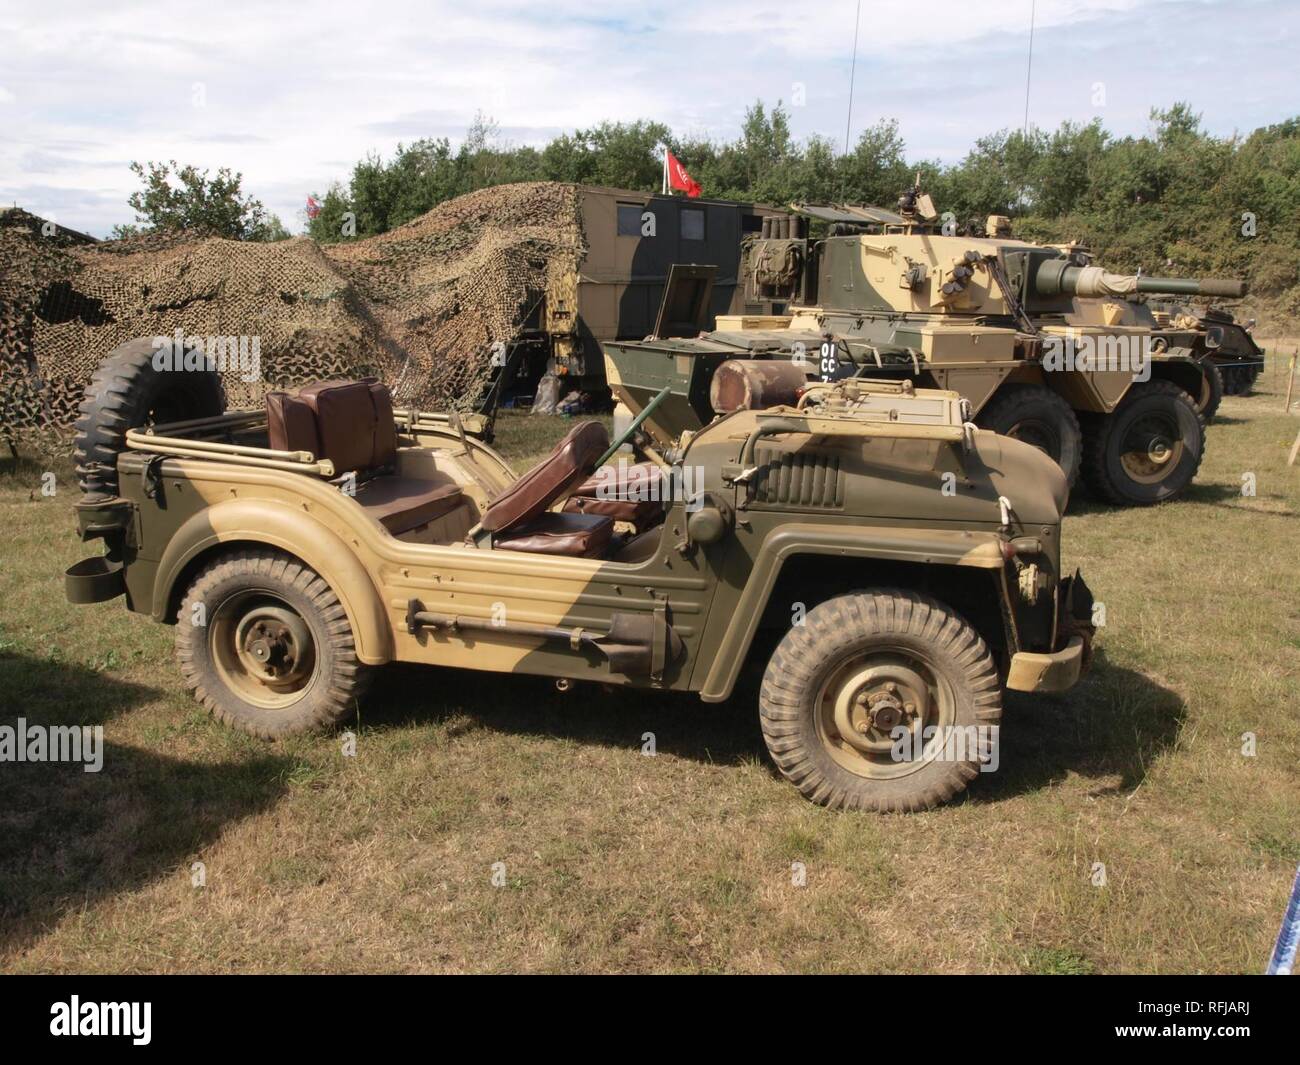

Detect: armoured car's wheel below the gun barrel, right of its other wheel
[1083, 381, 1205, 506]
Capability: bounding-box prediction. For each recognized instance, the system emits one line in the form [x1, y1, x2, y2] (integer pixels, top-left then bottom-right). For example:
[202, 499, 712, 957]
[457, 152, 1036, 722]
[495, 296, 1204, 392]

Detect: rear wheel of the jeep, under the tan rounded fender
[176, 550, 371, 740]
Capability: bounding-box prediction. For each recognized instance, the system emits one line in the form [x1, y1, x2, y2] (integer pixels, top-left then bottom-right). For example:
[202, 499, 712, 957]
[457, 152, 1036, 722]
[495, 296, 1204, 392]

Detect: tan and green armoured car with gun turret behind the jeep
[606, 189, 1245, 505]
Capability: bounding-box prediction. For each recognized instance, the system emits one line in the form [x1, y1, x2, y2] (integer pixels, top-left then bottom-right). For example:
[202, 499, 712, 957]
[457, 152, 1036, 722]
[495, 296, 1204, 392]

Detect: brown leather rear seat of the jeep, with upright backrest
[267, 377, 464, 536]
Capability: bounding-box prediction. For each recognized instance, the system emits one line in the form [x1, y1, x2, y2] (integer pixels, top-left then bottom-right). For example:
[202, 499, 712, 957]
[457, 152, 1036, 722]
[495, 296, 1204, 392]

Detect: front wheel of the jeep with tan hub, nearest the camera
[759, 589, 1002, 811]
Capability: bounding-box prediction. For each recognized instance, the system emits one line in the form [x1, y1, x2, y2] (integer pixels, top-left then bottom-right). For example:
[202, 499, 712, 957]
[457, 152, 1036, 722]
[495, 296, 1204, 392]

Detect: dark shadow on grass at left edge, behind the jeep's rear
[0, 654, 293, 954]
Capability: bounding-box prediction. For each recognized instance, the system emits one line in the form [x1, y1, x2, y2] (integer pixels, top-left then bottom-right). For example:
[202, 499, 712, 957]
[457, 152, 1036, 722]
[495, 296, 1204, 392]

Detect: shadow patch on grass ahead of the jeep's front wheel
[970, 648, 1187, 802]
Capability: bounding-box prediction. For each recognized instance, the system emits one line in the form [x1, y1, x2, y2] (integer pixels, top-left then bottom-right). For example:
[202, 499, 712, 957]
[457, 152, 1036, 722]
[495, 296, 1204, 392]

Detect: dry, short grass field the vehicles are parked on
[0, 358, 1300, 973]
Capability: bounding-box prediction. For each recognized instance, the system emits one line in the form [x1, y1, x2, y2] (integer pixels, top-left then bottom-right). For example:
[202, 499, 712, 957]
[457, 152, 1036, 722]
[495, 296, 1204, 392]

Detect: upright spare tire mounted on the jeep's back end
[73, 337, 226, 495]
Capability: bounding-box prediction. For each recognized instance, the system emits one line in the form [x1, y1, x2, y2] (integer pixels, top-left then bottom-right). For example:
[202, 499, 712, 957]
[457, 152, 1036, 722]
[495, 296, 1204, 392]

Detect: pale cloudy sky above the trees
[0, 0, 1300, 235]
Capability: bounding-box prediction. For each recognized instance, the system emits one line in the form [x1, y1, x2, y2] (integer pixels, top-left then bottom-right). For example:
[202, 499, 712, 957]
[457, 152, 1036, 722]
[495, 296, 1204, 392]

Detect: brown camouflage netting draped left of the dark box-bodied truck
[0, 182, 584, 442]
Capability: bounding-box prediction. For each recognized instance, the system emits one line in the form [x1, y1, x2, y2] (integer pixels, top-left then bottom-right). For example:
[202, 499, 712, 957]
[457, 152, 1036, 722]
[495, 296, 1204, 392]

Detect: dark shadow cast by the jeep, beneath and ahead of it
[364, 637, 1186, 802]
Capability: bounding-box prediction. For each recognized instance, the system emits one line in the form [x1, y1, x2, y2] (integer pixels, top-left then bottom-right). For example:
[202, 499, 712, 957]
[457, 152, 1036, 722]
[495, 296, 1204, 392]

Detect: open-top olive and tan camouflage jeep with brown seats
[66, 341, 1092, 810]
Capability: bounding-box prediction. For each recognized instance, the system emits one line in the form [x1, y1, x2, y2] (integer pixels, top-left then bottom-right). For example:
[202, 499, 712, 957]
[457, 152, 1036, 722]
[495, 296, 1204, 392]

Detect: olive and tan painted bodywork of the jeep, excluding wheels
[68, 382, 1086, 701]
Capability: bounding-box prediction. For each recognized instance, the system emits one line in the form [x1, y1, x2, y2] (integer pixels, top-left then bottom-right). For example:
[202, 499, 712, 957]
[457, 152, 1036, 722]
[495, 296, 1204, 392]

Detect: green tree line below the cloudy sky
[111, 101, 1300, 312]
